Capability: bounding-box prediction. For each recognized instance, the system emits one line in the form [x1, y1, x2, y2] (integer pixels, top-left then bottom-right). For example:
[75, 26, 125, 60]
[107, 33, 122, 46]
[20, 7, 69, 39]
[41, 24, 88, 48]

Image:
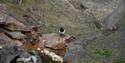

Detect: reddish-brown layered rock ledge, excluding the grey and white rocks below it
[0, 5, 74, 63]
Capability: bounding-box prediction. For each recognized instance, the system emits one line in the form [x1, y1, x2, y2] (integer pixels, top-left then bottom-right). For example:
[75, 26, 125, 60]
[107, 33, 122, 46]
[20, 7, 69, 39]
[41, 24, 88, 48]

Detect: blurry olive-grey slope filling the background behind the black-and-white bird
[0, 0, 125, 63]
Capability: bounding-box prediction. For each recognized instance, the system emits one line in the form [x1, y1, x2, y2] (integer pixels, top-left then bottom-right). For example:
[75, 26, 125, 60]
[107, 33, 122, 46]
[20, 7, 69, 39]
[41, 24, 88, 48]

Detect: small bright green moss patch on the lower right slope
[95, 49, 112, 58]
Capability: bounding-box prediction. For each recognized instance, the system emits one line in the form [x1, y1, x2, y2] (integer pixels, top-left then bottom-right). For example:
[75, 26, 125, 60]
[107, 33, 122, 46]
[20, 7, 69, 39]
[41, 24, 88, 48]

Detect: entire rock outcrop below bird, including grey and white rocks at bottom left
[0, 4, 74, 63]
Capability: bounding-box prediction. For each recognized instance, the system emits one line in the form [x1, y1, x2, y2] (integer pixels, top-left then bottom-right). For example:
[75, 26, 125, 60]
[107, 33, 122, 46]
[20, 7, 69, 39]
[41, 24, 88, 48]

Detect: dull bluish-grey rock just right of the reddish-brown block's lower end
[64, 40, 87, 63]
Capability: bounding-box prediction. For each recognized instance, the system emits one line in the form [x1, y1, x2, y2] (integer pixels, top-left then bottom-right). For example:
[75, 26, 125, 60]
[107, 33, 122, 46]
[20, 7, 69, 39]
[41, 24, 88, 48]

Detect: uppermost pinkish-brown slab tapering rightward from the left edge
[0, 4, 29, 31]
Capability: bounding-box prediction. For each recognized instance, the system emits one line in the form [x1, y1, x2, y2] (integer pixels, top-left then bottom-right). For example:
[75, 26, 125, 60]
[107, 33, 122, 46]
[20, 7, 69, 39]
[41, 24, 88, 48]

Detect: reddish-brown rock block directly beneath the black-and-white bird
[42, 33, 73, 57]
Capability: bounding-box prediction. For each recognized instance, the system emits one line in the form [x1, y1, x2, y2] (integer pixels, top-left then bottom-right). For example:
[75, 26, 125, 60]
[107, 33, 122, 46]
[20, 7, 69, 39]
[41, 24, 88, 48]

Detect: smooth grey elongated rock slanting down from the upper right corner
[103, 0, 125, 30]
